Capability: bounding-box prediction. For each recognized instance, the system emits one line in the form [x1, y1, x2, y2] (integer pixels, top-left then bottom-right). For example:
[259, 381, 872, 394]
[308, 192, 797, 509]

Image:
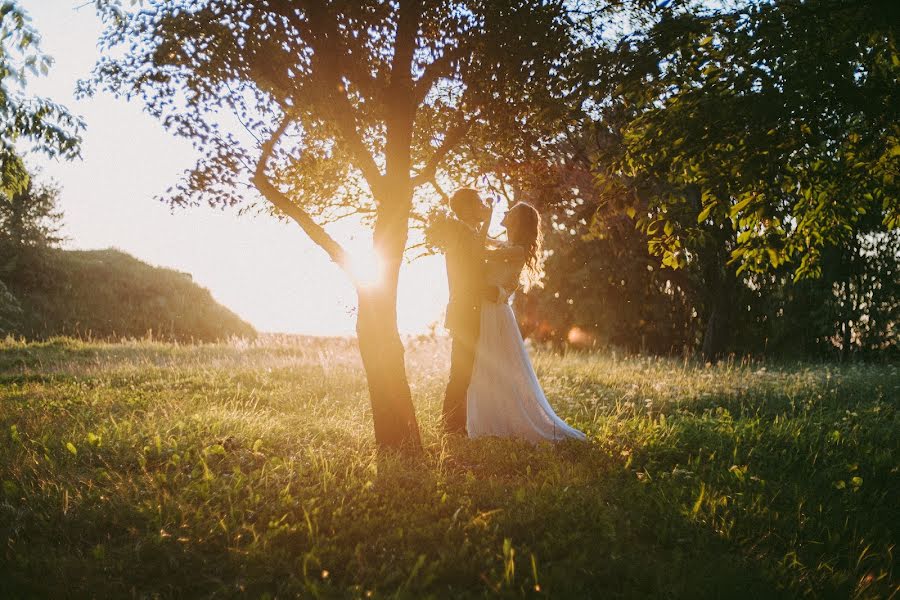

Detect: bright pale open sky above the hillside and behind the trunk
[15, 0, 447, 335]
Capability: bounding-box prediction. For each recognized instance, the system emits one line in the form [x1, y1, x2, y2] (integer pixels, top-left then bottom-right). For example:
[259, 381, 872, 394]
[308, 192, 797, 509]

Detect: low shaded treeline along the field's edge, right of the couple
[517, 219, 900, 360]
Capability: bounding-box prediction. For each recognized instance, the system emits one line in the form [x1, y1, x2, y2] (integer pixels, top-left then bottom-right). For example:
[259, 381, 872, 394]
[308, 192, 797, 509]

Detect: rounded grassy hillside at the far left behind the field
[0, 249, 256, 341]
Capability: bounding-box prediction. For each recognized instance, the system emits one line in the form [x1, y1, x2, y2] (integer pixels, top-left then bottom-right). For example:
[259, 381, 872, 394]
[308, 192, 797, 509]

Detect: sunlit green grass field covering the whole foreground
[0, 339, 900, 598]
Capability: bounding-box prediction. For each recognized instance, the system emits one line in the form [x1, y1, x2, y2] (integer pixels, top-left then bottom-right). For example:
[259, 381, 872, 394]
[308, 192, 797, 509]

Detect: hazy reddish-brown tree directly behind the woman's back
[488, 132, 695, 353]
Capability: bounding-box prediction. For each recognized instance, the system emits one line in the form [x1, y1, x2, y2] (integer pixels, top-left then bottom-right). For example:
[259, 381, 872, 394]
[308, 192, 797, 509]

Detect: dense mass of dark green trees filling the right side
[516, 0, 900, 358]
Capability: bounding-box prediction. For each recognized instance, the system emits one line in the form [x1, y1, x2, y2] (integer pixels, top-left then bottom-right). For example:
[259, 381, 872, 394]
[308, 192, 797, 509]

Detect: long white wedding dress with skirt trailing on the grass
[467, 255, 586, 442]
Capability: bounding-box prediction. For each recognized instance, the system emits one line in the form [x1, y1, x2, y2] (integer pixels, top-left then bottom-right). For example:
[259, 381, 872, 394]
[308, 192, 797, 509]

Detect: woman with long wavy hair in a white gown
[467, 202, 585, 442]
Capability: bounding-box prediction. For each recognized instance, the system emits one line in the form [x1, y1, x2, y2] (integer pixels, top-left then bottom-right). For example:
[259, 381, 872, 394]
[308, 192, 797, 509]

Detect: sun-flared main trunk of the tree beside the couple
[356, 195, 421, 451]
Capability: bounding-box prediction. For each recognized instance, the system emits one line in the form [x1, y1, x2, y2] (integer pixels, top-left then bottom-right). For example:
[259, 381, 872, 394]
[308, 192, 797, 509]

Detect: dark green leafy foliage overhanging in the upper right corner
[598, 0, 900, 278]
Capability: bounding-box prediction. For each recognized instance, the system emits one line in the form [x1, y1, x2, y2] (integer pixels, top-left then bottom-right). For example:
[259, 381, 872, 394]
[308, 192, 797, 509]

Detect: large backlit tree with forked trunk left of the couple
[85, 0, 604, 446]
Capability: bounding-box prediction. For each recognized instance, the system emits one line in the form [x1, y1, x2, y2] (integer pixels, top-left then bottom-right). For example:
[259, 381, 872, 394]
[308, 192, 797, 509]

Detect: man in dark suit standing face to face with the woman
[432, 188, 496, 435]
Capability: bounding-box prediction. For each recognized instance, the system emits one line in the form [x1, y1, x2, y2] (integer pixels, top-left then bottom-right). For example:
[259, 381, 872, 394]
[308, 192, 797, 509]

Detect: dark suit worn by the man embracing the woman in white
[442, 219, 488, 433]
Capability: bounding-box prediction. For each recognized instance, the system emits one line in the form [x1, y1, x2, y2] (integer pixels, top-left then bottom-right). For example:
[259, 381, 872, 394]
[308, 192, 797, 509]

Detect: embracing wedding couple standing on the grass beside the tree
[429, 188, 585, 442]
